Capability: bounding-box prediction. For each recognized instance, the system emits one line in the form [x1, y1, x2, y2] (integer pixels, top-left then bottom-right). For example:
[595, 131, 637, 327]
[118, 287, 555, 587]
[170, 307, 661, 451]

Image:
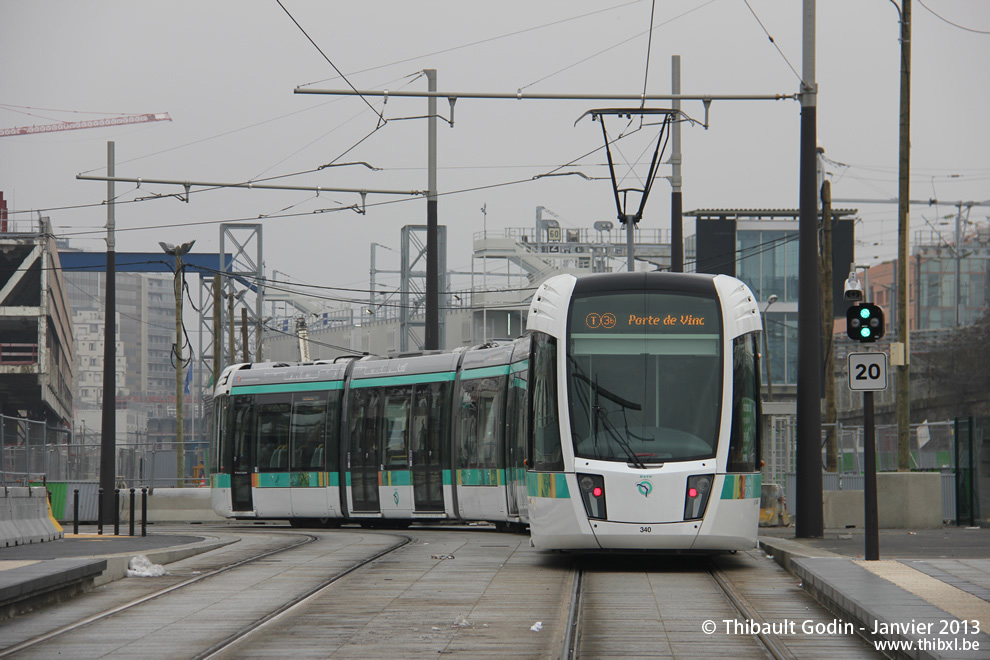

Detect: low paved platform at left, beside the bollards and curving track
[0, 526, 230, 621]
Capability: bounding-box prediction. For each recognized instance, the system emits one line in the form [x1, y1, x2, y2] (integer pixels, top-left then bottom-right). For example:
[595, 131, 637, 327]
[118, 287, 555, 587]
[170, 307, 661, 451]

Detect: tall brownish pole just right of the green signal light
[890, 0, 911, 471]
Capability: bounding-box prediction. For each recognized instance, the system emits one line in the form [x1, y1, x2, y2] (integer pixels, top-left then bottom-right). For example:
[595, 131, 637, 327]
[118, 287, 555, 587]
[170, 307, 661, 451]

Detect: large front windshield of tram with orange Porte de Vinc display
[567, 291, 722, 467]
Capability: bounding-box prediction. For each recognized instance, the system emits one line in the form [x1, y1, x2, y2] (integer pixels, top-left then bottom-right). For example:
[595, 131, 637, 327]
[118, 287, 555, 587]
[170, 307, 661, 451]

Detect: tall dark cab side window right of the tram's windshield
[726, 334, 760, 472]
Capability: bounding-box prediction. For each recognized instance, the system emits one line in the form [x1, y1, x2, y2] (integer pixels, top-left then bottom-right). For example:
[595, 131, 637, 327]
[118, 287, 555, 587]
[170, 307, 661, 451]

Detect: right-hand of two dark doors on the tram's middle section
[409, 383, 445, 512]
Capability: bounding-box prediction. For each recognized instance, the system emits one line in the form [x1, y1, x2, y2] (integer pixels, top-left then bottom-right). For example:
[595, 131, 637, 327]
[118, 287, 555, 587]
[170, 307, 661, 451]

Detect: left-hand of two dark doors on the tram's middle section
[348, 388, 381, 513]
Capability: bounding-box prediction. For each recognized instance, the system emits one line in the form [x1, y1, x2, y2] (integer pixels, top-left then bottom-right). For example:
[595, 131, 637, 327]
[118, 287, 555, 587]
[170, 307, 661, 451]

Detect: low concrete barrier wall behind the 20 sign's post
[822, 472, 942, 529]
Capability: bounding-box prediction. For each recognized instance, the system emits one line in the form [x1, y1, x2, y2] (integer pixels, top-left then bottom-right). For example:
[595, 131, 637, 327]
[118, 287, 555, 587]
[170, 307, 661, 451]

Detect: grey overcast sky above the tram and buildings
[0, 0, 990, 310]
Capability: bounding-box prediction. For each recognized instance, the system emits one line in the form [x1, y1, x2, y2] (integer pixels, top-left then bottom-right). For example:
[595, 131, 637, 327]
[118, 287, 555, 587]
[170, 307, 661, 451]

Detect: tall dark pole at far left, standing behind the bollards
[100, 142, 117, 525]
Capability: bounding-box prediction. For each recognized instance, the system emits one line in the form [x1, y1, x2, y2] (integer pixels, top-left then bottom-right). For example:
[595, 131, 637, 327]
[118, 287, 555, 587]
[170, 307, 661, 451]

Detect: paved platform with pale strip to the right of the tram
[759, 527, 990, 658]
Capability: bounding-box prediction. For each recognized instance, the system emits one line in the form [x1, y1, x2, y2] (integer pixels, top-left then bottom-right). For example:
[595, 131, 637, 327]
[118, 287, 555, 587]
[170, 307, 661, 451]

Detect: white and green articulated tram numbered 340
[211, 273, 761, 552]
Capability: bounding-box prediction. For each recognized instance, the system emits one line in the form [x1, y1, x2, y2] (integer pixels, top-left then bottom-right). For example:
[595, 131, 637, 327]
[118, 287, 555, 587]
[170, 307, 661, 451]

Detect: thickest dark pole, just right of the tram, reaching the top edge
[794, 0, 824, 538]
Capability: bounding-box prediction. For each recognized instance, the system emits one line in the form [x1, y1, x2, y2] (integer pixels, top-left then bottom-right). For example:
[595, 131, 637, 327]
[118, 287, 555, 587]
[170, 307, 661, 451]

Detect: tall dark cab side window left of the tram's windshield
[530, 333, 564, 472]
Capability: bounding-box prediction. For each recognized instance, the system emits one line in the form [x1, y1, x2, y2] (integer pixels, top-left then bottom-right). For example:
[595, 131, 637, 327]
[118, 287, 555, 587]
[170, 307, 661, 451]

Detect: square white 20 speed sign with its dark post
[849, 353, 887, 561]
